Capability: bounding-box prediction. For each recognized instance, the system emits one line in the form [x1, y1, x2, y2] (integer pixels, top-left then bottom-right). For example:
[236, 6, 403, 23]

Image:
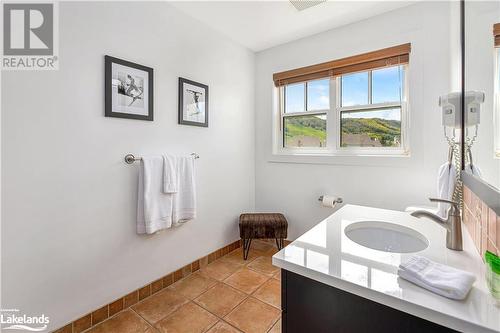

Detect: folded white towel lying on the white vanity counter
[398, 255, 476, 300]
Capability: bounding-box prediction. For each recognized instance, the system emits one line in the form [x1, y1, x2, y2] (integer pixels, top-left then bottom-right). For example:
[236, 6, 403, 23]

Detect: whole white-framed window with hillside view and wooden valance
[275, 45, 409, 155]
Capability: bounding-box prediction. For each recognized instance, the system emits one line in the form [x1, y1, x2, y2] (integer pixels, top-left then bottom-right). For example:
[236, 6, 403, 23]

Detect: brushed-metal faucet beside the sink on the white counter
[411, 198, 463, 251]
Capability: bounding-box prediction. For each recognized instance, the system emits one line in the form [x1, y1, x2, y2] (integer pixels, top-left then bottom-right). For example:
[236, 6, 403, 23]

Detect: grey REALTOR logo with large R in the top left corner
[2, 2, 59, 70]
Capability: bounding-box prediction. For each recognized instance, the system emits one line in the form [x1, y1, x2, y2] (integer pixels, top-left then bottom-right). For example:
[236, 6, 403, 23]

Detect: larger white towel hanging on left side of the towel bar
[137, 156, 173, 234]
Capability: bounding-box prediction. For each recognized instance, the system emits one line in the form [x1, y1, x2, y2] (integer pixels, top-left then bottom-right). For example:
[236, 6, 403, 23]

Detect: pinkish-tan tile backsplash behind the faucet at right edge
[463, 186, 500, 258]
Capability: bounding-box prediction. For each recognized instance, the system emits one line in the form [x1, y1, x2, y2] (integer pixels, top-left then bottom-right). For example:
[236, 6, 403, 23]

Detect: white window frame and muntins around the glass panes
[273, 64, 410, 156]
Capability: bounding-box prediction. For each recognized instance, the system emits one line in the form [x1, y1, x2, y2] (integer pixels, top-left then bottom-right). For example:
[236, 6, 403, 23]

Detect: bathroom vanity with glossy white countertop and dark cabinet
[273, 205, 500, 333]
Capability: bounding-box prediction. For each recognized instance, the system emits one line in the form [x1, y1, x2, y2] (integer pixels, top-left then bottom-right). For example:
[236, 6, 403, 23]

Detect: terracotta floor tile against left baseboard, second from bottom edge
[132, 289, 188, 324]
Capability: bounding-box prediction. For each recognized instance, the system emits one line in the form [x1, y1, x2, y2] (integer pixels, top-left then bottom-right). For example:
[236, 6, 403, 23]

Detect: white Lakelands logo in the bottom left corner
[0, 309, 50, 332]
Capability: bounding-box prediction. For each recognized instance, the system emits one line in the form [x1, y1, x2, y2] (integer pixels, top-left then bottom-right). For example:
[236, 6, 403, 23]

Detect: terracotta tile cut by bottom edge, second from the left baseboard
[155, 302, 217, 333]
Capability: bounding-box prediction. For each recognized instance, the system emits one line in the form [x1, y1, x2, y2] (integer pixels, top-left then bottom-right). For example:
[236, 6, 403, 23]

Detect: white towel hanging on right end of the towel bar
[172, 156, 196, 225]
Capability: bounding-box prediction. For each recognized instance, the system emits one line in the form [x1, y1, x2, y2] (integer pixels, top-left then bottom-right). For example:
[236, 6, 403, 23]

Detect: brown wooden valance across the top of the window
[273, 43, 411, 87]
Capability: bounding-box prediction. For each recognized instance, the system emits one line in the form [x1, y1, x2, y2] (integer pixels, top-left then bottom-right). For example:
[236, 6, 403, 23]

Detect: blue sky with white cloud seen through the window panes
[285, 66, 403, 120]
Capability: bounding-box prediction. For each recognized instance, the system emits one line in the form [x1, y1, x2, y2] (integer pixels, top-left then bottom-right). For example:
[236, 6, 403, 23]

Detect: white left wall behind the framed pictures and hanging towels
[2, 2, 255, 329]
